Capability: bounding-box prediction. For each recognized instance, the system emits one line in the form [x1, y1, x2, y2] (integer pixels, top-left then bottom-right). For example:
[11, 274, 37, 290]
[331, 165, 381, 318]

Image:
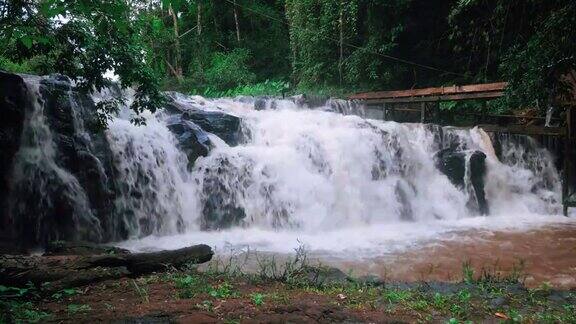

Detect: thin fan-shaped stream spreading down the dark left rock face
[9, 77, 102, 240]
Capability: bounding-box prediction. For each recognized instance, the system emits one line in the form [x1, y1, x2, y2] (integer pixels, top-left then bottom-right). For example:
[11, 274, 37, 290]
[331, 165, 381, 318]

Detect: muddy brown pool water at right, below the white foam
[206, 223, 576, 289]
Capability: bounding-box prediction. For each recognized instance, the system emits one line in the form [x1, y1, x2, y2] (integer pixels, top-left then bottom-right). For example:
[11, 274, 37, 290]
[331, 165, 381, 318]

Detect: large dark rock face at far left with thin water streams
[0, 73, 127, 246]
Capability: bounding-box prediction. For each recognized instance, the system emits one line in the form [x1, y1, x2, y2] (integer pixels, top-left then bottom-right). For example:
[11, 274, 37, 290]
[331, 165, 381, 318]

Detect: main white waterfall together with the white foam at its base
[113, 97, 570, 257]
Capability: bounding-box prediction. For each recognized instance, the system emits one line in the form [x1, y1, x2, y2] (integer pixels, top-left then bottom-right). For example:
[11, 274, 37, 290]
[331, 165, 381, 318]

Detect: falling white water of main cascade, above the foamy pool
[109, 97, 559, 231]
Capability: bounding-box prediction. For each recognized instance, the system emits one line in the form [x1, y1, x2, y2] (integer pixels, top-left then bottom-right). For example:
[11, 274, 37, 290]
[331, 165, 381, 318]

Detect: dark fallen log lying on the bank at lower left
[0, 244, 214, 291]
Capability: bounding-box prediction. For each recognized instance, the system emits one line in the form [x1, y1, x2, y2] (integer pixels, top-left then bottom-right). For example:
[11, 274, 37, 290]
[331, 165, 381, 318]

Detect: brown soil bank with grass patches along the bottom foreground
[11, 271, 576, 323]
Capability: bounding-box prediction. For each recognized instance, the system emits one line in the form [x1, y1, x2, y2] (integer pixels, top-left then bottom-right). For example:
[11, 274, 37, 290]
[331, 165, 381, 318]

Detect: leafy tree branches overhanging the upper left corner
[0, 0, 163, 124]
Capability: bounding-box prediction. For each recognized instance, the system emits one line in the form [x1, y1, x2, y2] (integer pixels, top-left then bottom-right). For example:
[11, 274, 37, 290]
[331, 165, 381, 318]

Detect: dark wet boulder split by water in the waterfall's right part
[436, 147, 489, 215]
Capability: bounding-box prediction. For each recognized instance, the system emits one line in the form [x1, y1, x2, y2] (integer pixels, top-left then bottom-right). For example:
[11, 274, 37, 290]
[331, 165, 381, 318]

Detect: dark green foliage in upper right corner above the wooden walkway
[449, 0, 576, 111]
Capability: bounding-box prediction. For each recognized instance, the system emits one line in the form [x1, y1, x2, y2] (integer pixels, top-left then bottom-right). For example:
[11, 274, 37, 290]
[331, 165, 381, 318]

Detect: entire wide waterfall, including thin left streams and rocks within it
[0, 73, 560, 251]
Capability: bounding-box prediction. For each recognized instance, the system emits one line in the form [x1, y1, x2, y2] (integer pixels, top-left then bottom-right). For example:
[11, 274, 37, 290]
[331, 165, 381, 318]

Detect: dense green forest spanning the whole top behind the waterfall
[0, 0, 576, 116]
